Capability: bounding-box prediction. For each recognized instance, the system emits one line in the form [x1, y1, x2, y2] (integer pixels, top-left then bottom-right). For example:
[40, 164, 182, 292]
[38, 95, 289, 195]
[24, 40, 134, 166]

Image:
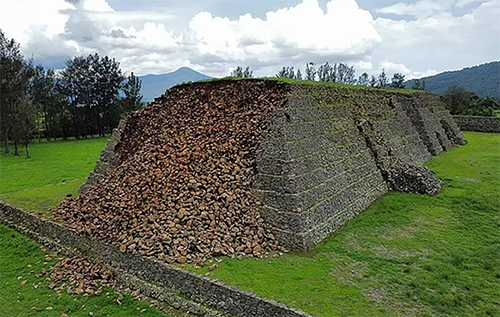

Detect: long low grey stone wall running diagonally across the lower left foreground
[0, 202, 311, 317]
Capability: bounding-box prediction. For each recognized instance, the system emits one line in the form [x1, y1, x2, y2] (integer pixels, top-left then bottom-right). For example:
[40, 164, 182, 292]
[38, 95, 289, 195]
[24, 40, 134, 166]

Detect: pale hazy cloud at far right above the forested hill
[372, 0, 500, 73]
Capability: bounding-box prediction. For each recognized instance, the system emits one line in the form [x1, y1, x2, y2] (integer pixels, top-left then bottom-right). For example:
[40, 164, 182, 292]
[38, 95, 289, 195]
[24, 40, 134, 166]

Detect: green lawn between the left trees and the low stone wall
[0, 138, 107, 212]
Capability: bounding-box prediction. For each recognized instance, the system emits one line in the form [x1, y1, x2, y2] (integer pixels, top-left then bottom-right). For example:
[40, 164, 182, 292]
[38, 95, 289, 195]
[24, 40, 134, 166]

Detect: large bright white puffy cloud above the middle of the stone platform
[190, 0, 381, 62]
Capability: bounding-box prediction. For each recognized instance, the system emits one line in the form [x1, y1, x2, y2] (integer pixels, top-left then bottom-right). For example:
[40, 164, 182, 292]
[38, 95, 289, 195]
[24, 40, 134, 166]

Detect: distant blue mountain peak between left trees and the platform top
[139, 67, 212, 102]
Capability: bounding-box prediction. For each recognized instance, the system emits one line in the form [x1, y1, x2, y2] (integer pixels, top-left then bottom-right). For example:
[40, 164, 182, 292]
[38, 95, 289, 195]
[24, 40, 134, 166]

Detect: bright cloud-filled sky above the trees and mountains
[0, 0, 500, 79]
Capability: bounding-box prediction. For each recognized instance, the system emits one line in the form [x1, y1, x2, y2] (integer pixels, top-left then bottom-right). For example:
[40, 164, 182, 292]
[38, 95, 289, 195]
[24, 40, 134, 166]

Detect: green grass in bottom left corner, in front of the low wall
[0, 225, 165, 317]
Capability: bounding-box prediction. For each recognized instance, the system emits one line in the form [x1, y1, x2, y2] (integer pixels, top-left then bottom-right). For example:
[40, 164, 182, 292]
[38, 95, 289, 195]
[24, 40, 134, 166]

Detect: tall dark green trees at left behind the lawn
[0, 30, 143, 157]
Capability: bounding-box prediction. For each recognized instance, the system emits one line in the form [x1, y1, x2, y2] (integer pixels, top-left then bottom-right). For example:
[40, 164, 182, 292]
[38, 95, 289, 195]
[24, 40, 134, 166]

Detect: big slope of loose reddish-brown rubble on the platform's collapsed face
[54, 81, 286, 264]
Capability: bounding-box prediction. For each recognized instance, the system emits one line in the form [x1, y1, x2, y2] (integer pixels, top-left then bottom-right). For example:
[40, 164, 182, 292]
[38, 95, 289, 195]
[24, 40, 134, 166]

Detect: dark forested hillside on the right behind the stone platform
[405, 61, 500, 98]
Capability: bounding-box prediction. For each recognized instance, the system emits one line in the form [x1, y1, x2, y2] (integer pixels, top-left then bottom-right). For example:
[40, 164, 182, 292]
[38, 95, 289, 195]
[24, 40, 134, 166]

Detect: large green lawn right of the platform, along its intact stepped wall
[188, 133, 500, 316]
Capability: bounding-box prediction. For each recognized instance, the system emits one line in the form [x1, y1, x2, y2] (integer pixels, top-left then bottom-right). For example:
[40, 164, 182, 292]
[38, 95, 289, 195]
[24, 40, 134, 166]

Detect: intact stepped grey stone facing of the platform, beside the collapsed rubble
[83, 81, 466, 251]
